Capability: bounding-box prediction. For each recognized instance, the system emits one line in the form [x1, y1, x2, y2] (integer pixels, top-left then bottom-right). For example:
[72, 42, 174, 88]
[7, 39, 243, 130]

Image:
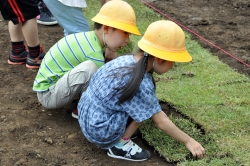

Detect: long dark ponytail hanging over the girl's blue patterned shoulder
[117, 49, 155, 104]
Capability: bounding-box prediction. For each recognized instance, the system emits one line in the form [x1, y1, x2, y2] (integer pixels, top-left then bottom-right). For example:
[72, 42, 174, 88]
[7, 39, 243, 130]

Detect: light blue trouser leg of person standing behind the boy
[44, 0, 90, 36]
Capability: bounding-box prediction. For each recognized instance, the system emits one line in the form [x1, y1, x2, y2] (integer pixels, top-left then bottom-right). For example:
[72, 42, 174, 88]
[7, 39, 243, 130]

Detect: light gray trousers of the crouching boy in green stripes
[37, 60, 97, 109]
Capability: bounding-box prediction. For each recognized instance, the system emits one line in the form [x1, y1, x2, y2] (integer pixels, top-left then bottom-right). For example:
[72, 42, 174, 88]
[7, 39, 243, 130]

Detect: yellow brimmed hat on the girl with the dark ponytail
[138, 20, 192, 62]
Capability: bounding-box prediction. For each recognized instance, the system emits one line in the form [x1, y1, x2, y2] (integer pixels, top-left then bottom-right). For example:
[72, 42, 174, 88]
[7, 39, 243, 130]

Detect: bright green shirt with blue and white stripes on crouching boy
[33, 31, 104, 92]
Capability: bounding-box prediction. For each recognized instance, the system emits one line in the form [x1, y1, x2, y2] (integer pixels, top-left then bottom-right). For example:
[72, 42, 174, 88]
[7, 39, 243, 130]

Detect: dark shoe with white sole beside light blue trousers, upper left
[36, 1, 57, 25]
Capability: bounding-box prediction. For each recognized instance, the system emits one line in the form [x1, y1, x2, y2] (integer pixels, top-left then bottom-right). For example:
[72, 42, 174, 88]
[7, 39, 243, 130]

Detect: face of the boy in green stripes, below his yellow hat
[105, 27, 130, 51]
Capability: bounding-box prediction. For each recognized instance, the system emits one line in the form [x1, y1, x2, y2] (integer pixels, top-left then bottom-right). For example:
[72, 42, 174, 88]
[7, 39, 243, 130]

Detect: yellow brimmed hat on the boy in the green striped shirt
[92, 0, 141, 36]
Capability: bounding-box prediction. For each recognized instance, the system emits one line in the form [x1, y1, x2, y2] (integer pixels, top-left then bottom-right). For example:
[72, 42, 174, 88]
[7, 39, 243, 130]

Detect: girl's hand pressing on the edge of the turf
[185, 138, 205, 158]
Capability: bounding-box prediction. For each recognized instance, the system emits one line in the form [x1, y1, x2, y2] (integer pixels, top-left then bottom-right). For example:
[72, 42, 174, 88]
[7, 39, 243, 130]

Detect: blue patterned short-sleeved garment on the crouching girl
[78, 55, 161, 149]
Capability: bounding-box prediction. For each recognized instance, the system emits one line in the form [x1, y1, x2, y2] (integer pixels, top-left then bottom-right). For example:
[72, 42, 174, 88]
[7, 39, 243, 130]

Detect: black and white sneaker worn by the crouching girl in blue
[107, 140, 150, 161]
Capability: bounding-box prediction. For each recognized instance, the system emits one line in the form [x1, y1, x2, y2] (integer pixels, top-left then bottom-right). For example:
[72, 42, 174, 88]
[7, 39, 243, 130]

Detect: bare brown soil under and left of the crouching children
[0, 15, 170, 166]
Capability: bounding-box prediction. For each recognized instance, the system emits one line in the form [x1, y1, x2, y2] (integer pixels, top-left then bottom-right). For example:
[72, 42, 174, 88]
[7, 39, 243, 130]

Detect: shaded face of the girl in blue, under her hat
[153, 58, 174, 74]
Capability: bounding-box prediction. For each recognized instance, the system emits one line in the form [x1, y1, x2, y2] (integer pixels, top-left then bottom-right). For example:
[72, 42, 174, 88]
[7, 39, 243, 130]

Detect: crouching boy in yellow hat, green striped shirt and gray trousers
[33, 0, 140, 109]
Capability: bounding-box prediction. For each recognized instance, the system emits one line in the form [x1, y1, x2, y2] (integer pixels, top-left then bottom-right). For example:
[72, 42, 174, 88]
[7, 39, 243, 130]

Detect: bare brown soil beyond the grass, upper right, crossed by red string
[145, 0, 250, 76]
